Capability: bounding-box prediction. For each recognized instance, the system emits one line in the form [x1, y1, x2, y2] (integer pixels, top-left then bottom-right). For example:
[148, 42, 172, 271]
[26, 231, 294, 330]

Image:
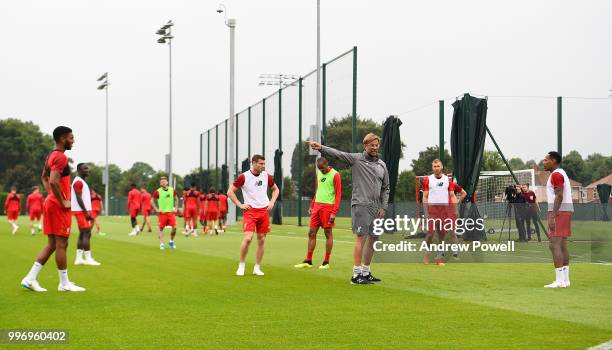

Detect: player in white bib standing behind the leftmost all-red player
[70, 163, 100, 266]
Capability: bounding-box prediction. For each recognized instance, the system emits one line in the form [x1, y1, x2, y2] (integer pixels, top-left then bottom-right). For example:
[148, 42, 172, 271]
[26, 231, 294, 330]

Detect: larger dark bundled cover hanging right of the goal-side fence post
[451, 94, 487, 241]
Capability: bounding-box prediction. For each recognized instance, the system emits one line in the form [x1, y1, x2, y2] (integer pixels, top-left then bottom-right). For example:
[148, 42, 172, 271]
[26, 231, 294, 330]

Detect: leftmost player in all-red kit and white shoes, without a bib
[21, 126, 85, 292]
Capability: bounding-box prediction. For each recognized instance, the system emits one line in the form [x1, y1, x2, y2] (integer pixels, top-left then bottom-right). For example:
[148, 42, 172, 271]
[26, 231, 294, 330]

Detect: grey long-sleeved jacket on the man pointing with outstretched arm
[320, 146, 389, 210]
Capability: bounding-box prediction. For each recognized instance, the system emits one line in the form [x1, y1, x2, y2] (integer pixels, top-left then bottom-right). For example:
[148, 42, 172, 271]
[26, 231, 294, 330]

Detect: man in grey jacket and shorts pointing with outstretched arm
[306, 133, 389, 284]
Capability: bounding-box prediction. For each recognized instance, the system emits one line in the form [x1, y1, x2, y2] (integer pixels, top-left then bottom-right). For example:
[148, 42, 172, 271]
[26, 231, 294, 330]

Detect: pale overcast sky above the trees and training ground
[0, 0, 612, 174]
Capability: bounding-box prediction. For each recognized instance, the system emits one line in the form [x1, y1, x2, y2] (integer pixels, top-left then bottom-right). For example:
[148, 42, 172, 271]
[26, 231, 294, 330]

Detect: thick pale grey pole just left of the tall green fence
[217, 4, 238, 224]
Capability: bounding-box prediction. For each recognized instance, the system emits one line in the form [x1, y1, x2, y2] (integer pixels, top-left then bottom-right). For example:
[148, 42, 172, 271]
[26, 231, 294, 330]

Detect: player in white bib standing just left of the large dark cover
[423, 159, 457, 266]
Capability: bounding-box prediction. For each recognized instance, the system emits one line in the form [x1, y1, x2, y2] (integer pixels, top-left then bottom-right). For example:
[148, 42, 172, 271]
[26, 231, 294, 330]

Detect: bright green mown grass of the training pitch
[0, 217, 612, 349]
